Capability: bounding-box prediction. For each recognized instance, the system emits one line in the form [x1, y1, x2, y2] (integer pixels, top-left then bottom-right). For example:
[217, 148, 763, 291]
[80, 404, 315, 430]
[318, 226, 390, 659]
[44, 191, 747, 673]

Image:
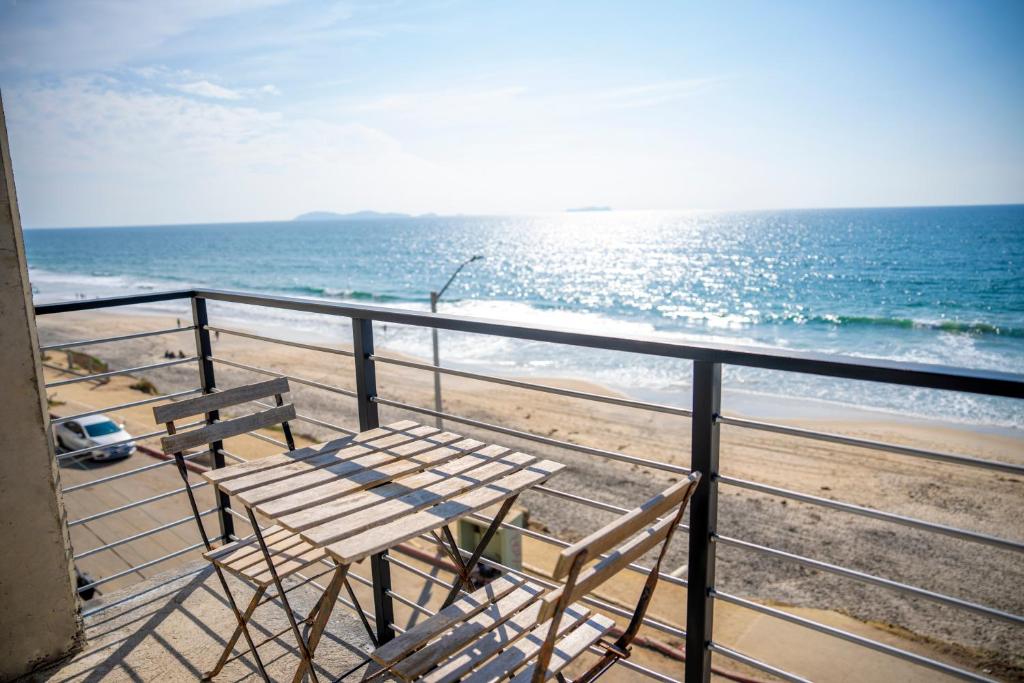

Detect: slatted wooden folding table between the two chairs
[203, 421, 564, 681]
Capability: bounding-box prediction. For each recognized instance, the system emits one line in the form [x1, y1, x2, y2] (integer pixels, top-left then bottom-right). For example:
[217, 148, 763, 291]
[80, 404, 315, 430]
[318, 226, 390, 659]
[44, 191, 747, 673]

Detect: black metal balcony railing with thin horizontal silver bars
[36, 289, 1024, 683]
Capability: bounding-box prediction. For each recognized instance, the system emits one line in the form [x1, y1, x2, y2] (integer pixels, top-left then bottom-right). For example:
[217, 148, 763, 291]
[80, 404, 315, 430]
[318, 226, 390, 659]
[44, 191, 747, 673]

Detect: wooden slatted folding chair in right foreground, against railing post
[365, 472, 700, 683]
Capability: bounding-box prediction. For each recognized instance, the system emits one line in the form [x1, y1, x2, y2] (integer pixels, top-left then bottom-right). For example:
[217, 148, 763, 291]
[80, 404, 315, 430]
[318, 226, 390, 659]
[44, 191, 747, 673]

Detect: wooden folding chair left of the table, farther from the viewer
[153, 378, 361, 681]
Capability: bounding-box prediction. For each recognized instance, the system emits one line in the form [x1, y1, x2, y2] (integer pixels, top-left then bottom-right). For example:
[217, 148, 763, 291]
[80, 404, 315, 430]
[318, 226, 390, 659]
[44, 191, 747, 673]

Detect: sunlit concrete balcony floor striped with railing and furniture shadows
[22, 562, 372, 683]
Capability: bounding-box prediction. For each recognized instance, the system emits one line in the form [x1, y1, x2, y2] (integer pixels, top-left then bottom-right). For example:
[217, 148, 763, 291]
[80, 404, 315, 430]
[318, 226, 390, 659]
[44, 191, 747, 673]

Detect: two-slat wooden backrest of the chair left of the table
[153, 377, 295, 455]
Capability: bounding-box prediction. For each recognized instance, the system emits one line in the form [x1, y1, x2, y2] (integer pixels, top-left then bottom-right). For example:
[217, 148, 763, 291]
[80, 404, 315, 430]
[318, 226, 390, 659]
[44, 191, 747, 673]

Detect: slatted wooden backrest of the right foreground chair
[539, 472, 700, 631]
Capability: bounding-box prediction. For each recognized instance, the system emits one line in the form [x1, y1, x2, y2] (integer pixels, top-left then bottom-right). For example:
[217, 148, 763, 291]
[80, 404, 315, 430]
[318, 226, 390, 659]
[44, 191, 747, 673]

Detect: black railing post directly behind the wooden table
[352, 317, 394, 645]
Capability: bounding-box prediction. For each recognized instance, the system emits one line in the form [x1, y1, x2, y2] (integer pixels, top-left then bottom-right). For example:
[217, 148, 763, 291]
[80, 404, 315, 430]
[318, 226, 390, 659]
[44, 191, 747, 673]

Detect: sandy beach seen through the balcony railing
[38, 311, 1024, 679]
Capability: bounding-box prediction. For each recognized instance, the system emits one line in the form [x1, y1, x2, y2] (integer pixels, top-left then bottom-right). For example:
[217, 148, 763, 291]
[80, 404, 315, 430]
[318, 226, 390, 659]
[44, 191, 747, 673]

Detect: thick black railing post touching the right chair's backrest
[685, 360, 722, 683]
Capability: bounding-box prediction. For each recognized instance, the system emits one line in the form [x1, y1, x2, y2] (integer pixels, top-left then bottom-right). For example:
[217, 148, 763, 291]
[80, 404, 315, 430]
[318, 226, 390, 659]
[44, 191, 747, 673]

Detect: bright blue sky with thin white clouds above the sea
[0, 0, 1024, 227]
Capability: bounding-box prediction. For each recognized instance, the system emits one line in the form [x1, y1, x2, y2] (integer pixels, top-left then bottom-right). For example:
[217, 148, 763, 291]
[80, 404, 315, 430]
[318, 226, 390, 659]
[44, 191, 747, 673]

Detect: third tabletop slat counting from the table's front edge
[276, 444, 509, 531]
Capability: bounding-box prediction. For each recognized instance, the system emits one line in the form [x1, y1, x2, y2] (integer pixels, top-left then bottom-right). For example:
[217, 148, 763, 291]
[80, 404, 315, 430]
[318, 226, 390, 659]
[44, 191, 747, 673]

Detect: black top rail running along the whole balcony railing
[36, 289, 1024, 398]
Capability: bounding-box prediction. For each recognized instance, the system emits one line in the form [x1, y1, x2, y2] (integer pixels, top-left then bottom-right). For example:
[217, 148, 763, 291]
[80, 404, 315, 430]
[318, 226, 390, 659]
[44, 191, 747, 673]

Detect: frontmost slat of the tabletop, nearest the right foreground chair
[327, 460, 565, 564]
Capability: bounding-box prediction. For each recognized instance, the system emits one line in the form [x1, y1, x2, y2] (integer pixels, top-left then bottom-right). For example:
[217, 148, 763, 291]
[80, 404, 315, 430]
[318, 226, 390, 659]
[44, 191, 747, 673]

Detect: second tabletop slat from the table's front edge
[302, 453, 537, 546]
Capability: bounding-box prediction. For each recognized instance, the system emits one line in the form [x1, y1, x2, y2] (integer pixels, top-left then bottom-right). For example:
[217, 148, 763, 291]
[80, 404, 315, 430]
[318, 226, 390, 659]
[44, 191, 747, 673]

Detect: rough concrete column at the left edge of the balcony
[0, 92, 82, 680]
